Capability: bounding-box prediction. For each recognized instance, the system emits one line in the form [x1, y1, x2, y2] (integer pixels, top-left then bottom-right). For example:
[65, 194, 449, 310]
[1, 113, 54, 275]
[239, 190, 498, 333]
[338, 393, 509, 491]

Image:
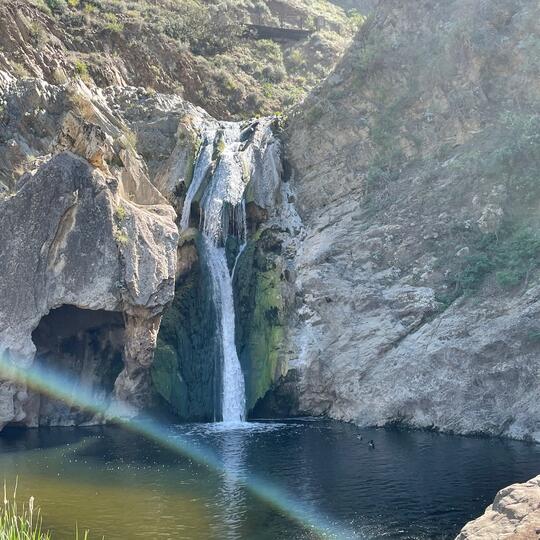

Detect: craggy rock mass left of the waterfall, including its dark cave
[0, 77, 178, 425]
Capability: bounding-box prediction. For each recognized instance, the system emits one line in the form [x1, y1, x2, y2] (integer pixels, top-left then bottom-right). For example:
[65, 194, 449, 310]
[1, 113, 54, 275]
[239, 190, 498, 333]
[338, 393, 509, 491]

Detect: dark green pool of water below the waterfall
[0, 420, 540, 540]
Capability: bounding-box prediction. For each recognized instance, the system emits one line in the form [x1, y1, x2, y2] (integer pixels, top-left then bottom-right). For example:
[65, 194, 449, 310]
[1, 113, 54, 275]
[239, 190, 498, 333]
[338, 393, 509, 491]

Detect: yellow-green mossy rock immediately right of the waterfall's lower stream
[233, 229, 285, 413]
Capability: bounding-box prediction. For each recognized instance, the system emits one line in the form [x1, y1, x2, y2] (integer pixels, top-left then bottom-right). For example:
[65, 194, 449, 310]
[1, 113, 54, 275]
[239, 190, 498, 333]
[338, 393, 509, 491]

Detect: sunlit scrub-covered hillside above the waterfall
[0, 0, 358, 118]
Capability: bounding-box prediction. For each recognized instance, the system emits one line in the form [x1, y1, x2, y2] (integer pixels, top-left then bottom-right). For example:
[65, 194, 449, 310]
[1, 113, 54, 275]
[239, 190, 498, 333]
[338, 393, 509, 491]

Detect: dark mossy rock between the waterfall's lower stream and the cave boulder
[152, 233, 221, 421]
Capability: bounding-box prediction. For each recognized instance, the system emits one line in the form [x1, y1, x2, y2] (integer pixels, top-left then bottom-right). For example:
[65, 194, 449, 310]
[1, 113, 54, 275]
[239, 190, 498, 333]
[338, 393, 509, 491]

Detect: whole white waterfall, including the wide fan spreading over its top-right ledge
[181, 120, 279, 422]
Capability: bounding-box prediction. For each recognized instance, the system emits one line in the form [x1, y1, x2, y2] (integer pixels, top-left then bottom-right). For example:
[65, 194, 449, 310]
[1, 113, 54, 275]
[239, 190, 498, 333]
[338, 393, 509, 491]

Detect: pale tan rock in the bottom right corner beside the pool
[456, 476, 540, 540]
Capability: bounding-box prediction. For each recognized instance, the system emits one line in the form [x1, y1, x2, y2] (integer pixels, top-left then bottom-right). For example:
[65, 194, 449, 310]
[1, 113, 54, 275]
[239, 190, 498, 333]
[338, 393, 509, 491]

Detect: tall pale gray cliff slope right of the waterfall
[280, 0, 540, 440]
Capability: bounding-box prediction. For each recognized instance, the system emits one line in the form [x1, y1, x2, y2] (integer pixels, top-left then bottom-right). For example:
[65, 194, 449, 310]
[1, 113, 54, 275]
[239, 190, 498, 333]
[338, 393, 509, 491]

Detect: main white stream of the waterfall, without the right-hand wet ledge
[181, 123, 249, 422]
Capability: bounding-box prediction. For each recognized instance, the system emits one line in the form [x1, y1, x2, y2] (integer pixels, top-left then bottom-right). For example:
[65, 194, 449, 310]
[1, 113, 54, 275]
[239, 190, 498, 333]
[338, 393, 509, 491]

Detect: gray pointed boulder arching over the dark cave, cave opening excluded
[0, 152, 178, 425]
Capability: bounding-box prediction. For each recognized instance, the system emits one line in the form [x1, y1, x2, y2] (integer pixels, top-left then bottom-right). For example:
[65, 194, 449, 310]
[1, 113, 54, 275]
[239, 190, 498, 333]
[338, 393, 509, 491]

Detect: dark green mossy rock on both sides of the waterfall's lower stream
[152, 224, 292, 421]
